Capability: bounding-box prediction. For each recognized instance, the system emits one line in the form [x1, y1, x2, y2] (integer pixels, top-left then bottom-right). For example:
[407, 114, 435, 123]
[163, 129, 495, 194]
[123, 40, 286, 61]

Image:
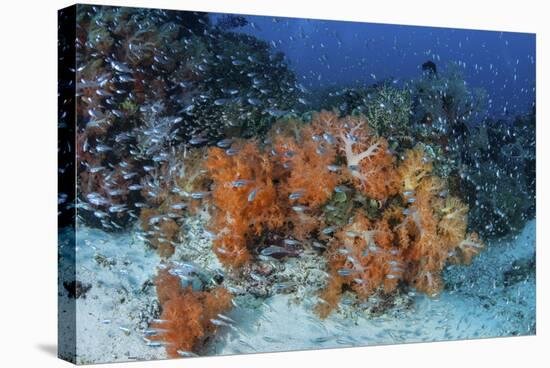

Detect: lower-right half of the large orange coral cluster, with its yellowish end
[316, 143, 483, 318]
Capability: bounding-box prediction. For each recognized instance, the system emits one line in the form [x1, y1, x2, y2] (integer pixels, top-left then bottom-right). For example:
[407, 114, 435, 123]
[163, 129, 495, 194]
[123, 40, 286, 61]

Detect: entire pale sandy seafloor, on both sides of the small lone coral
[60, 219, 536, 364]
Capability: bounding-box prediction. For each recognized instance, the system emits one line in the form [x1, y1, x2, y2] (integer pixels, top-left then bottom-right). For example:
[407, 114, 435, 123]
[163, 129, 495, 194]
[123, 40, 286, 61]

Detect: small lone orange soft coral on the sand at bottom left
[150, 270, 231, 358]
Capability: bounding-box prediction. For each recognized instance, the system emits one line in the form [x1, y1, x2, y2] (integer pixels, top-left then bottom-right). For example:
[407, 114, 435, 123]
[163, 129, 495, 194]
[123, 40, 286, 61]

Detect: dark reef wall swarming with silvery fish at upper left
[76, 5, 299, 230]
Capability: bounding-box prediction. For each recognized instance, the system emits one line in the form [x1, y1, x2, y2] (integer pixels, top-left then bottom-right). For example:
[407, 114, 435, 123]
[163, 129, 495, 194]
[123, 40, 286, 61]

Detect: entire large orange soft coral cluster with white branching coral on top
[205, 111, 483, 317]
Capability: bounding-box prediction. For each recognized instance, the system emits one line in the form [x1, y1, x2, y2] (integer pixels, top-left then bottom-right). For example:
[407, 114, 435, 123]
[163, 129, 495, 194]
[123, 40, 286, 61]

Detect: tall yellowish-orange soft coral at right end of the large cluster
[396, 146, 481, 295]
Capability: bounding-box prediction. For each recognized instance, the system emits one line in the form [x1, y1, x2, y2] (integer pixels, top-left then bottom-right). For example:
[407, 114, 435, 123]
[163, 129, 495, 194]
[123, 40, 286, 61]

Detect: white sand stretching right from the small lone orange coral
[209, 220, 535, 354]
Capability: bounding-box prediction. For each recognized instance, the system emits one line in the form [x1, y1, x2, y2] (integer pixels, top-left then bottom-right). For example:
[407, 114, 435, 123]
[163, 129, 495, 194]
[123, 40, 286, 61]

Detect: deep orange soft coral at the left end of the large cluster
[204, 142, 284, 267]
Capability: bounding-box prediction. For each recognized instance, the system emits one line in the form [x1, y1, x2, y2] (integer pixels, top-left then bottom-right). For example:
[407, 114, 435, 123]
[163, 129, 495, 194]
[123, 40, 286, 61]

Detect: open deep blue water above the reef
[212, 14, 536, 117]
